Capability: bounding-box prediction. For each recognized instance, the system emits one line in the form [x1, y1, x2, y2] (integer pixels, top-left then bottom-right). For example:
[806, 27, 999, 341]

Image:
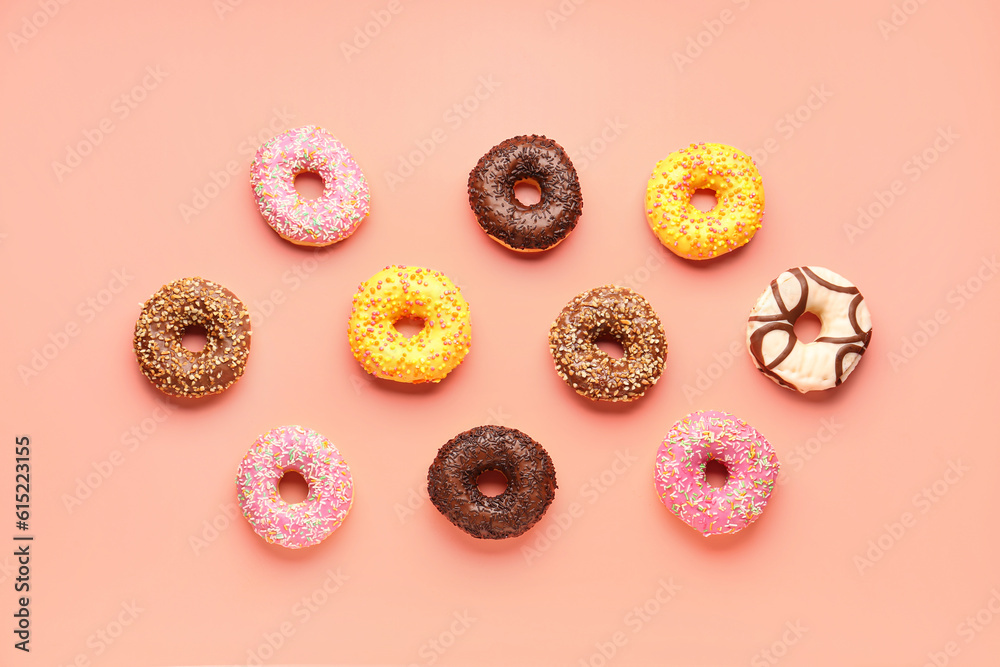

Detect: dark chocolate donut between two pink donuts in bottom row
[427, 426, 556, 540]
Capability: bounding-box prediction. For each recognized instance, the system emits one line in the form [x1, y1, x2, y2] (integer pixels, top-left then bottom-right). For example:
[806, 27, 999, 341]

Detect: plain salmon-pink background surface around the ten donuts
[0, 0, 1000, 667]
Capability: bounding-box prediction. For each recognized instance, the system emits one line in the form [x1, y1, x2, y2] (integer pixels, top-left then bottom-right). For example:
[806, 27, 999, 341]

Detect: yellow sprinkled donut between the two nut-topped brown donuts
[347, 265, 472, 383]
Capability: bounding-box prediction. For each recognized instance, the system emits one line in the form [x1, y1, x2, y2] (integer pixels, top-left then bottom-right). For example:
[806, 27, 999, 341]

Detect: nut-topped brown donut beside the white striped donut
[549, 285, 667, 401]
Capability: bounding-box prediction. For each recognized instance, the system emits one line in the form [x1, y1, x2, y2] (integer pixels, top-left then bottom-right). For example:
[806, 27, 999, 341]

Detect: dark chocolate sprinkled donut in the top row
[469, 134, 583, 252]
